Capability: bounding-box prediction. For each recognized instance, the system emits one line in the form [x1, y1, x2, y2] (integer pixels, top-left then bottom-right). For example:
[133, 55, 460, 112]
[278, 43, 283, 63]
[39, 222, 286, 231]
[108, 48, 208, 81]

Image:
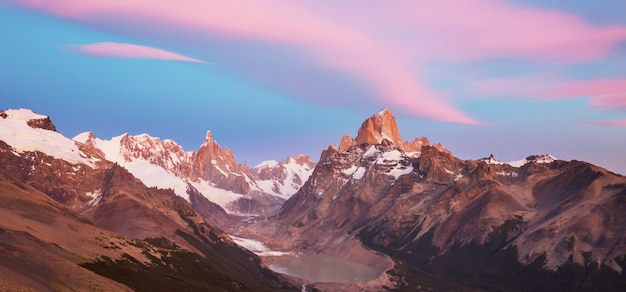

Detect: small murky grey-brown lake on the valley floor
[270, 255, 378, 284]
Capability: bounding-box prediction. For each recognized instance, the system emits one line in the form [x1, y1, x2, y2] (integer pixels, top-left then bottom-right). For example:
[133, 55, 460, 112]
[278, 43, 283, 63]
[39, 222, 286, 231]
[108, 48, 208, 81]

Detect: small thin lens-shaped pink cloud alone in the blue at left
[71, 42, 205, 64]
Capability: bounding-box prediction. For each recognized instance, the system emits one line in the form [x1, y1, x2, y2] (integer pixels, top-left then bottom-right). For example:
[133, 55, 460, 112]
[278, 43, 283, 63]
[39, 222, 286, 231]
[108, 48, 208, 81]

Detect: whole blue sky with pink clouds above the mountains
[0, 0, 626, 174]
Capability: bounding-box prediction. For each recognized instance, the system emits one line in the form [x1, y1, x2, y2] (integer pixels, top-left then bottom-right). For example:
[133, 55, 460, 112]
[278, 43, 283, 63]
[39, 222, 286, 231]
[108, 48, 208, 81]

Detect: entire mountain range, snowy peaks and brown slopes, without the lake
[0, 109, 626, 291]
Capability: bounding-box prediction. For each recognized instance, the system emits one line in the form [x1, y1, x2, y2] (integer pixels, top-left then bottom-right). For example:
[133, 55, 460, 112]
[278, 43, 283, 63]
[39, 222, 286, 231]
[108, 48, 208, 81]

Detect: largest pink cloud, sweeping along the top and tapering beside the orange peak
[13, 0, 626, 124]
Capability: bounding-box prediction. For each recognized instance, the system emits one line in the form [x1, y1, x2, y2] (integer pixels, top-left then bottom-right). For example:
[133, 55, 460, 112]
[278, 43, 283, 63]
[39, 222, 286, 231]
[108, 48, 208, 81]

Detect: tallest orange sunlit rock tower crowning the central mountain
[356, 108, 402, 146]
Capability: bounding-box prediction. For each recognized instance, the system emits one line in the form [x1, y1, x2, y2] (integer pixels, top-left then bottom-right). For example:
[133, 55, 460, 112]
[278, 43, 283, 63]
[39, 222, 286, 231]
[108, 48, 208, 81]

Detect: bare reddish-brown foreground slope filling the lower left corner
[0, 167, 296, 291]
